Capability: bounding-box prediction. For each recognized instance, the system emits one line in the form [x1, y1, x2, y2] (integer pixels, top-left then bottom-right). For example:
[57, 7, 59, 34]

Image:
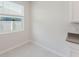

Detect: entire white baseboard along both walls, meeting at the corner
[0, 40, 68, 57]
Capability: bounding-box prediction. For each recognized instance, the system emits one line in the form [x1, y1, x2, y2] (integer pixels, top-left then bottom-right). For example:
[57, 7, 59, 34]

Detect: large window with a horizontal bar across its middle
[0, 1, 24, 33]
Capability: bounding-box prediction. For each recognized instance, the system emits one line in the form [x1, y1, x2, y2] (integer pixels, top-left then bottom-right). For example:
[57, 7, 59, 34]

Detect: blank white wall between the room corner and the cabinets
[32, 1, 70, 56]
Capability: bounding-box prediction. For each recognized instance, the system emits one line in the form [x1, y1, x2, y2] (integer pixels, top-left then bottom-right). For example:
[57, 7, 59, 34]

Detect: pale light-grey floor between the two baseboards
[0, 43, 57, 57]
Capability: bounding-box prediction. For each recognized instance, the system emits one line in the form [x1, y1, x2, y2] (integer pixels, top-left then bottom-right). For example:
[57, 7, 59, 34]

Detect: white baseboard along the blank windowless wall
[32, 41, 68, 57]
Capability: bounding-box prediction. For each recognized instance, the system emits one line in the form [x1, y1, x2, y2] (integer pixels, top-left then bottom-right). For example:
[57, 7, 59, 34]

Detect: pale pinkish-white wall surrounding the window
[0, 1, 30, 51]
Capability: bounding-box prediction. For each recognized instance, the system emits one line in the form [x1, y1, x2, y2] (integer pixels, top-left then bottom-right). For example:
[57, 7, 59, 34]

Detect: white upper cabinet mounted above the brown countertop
[72, 1, 79, 23]
